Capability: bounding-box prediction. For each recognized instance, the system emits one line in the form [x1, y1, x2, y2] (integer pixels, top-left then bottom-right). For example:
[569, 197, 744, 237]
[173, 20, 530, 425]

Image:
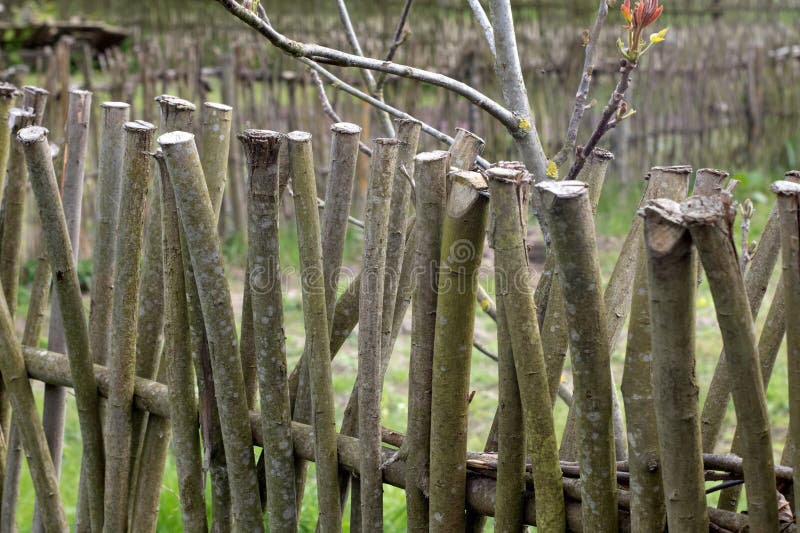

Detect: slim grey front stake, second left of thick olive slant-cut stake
[352, 139, 399, 531]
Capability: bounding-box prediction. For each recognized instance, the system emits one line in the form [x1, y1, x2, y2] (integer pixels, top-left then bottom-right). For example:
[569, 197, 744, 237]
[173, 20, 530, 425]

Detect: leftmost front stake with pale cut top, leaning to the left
[17, 126, 105, 531]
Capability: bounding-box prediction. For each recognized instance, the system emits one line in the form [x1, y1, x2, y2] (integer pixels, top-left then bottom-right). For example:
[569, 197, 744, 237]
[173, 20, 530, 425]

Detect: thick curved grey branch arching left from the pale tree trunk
[217, 0, 530, 132]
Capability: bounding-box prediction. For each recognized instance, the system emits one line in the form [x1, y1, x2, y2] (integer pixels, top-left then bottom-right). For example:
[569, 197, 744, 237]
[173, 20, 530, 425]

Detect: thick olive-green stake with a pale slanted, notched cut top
[428, 171, 488, 532]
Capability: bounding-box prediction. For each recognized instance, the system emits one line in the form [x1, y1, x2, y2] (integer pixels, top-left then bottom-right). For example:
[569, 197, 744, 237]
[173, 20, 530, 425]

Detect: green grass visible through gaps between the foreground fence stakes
[9, 167, 788, 531]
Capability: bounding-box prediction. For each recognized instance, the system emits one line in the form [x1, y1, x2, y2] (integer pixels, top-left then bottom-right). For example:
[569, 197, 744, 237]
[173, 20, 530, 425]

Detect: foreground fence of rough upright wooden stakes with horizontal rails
[0, 77, 800, 532]
